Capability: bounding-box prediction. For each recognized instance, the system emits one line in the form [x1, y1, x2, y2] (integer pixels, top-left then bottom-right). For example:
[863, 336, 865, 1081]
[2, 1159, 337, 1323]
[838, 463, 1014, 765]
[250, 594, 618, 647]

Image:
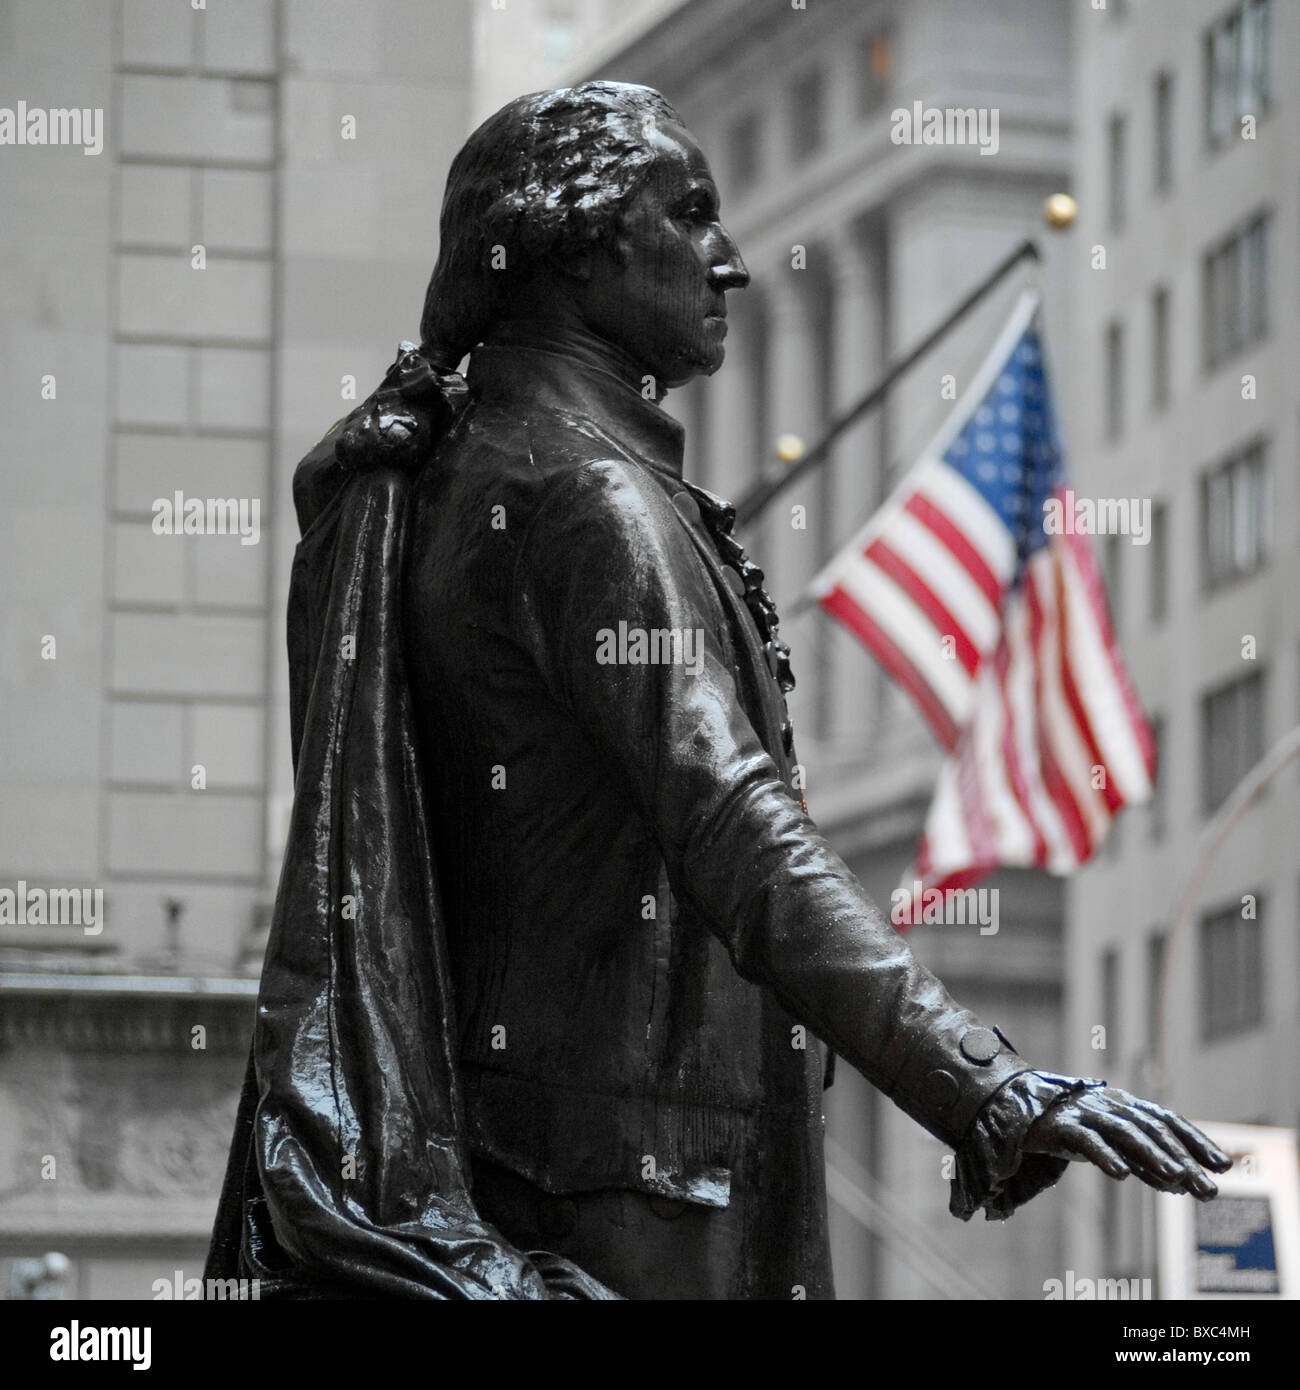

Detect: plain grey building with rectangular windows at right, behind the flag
[1065, 0, 1300, 1276]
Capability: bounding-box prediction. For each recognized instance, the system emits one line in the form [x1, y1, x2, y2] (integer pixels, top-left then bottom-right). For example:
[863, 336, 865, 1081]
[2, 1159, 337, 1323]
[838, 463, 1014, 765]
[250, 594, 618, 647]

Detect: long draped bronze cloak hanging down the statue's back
[204, 353, 616, 1300]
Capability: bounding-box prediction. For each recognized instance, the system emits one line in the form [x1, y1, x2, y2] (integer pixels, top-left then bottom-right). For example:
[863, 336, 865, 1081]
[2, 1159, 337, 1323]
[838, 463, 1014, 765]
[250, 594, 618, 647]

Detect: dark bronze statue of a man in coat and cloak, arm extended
[209, 82, 1229, 1298]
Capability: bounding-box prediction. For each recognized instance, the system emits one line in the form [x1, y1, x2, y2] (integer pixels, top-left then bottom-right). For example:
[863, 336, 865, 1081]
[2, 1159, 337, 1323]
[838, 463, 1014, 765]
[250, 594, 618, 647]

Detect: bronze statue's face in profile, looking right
[580, 124, 749, 389]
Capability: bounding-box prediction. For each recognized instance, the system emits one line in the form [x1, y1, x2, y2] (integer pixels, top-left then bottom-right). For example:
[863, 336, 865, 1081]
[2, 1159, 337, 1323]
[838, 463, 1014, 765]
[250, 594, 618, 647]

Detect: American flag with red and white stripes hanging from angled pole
[812, 292, 1155, 920]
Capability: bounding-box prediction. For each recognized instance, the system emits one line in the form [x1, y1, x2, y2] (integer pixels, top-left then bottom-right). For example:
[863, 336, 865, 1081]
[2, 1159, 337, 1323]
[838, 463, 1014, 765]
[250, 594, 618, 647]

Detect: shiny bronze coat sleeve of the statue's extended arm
[514, 461, 1027, 1148]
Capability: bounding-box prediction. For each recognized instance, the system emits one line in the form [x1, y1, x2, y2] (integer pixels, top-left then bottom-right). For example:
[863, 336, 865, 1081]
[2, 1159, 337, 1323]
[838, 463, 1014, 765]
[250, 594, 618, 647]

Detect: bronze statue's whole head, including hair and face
[420, 82, 749, 389]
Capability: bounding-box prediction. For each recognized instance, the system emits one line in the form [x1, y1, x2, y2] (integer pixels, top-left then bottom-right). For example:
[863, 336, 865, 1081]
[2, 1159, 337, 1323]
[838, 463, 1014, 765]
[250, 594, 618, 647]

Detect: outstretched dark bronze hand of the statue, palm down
[1023, 1086, 1232, 1202]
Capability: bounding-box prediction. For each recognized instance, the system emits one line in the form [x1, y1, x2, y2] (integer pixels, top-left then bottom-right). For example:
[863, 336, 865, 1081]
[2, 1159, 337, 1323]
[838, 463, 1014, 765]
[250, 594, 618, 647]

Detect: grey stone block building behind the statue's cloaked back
[0, 0, 471, 1298]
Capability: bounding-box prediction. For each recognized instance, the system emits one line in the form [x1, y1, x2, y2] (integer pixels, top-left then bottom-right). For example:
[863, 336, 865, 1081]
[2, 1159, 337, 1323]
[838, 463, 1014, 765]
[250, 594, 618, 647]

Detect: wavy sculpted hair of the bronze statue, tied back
[420, 82, 681, 368]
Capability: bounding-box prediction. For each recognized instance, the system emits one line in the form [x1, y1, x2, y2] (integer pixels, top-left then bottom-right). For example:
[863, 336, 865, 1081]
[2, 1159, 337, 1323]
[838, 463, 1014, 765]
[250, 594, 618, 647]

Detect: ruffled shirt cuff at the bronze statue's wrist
[948, 1072, 1105, 1220]
